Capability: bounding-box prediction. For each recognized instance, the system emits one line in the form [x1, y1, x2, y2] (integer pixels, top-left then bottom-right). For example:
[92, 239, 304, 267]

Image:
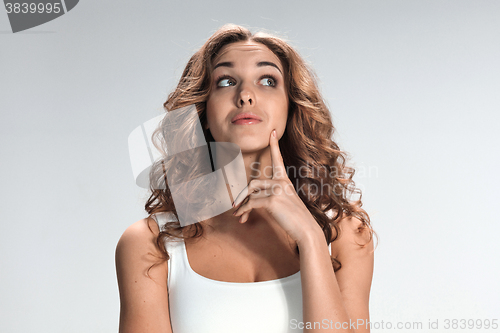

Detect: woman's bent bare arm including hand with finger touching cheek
[233, 130, 373, 333]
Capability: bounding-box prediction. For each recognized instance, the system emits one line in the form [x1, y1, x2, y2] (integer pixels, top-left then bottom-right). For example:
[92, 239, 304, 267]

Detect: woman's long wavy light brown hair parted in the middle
[145, 24, 375, 271]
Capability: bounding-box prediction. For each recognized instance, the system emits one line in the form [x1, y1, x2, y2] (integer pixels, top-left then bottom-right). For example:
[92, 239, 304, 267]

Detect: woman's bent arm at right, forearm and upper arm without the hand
[298, 217, 373, 332]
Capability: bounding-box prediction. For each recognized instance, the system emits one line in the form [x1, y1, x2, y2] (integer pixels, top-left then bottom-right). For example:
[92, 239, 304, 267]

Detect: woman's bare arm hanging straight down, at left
[116, 219, 172, 333]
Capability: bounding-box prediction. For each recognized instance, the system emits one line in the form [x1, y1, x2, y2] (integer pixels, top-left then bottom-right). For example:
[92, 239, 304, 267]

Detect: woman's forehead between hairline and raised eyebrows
[213, 41, 283, 72]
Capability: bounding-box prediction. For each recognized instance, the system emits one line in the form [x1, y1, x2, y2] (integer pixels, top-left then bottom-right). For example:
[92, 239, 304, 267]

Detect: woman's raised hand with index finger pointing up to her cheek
[233, 130, 321, 244]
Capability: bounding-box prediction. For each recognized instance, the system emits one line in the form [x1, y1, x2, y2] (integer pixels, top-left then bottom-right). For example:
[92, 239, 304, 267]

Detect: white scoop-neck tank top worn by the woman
[153, 213, 332, 333]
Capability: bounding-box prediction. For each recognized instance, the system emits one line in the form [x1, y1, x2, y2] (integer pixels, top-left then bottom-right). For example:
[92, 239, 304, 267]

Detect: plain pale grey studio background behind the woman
[0, 0, 500, 332]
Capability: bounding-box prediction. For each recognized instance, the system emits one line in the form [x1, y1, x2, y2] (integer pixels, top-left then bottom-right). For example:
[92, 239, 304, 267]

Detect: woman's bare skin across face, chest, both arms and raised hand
[116, 42, 373, 332]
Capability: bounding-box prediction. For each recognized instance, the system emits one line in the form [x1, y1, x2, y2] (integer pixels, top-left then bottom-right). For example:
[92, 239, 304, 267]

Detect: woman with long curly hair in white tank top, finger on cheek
[116, 25, 373, 333]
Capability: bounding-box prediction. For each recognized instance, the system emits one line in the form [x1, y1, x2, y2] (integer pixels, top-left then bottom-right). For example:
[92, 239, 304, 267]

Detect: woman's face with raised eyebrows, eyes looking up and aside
[206, 42, 288, 153]
